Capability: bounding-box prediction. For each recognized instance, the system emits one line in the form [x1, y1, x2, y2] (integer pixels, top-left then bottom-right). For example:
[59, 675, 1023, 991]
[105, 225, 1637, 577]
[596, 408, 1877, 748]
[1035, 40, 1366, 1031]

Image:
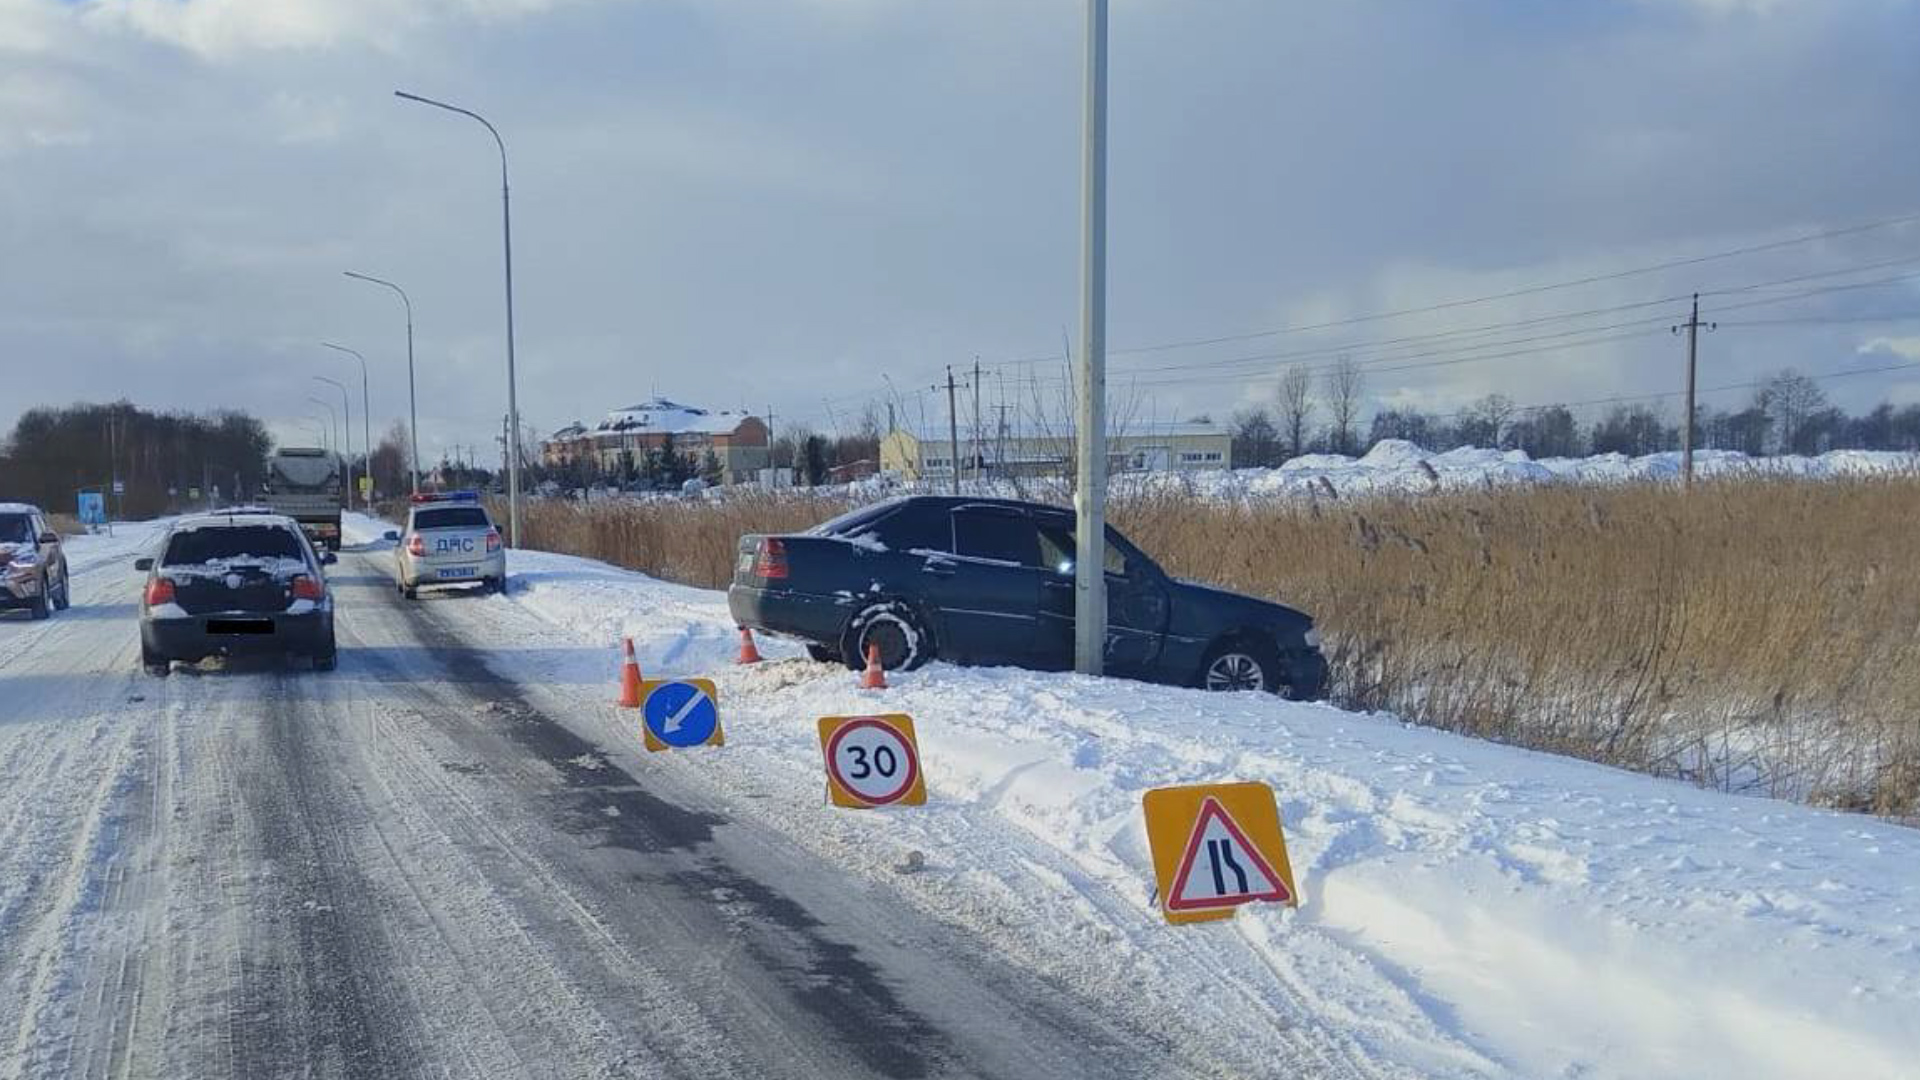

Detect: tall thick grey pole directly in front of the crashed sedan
[1073, 0, 1106, 675]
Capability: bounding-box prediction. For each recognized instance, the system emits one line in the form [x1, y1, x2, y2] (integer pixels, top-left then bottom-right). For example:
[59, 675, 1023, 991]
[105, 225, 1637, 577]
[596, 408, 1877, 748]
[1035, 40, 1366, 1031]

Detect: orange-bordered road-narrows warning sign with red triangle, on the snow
[1142, 784, 1300, 922]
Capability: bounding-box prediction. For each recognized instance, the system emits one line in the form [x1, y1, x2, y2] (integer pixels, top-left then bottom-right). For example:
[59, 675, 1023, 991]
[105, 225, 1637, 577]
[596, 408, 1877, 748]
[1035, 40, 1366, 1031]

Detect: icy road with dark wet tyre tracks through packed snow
[0, 526, 1274, 1078]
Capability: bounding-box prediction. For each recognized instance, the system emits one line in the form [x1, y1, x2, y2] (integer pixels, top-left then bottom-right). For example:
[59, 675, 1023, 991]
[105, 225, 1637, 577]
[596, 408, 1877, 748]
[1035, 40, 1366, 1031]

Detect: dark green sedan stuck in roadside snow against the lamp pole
[728, 496, 1327, 700]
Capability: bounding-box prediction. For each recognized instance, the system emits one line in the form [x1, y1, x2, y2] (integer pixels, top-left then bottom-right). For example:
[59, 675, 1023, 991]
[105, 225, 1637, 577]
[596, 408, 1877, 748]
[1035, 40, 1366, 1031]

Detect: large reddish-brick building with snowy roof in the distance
[540, 398, 770, 484]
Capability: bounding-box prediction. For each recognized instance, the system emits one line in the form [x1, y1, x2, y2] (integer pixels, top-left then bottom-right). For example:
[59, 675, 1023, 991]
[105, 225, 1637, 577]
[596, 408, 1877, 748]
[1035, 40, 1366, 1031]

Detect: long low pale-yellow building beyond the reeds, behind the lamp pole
[879, 423, 1233, 482]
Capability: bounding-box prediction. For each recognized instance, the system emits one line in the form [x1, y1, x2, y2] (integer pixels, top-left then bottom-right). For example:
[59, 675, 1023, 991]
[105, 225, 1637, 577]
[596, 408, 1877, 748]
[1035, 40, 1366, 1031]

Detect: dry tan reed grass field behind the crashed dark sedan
[495, 477, 1920, 817]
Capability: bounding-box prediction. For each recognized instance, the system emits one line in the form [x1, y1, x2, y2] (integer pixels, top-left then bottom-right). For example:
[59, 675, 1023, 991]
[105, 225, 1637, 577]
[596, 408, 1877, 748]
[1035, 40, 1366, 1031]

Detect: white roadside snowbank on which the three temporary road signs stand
[349, 511, 1920, 1078]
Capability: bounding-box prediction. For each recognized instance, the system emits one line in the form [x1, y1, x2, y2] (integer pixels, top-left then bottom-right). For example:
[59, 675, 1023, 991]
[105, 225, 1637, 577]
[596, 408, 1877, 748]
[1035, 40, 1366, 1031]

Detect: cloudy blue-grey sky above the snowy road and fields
[0, 0, 1920, 457]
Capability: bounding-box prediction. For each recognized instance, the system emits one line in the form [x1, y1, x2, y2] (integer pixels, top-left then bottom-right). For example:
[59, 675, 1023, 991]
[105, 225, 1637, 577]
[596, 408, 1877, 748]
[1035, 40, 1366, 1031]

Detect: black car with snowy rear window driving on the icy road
[134, 513, 336, 675]
